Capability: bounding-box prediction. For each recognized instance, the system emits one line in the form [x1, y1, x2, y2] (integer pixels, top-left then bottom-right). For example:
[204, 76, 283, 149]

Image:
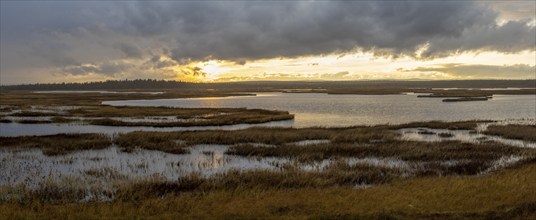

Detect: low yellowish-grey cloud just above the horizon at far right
[400, 63, 536, 79]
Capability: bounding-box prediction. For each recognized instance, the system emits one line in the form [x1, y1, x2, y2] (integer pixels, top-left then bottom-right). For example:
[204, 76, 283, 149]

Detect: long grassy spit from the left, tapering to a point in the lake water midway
[3, 105, 294, 127]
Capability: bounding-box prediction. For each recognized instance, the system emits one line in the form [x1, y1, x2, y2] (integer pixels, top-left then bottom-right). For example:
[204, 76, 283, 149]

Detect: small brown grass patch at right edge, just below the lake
[483, 125, 536, 141]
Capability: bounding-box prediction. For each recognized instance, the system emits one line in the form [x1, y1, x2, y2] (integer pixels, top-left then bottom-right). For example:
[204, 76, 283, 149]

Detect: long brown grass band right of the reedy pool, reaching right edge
[227, 141, 536, 162]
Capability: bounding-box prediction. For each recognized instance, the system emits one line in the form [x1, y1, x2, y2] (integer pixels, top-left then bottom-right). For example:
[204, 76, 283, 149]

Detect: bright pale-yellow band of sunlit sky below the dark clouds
[196, 50, 536, 82]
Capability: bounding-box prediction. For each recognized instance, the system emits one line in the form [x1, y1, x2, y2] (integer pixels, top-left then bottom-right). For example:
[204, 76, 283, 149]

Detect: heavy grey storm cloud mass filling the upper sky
[0, 1, 536, 80]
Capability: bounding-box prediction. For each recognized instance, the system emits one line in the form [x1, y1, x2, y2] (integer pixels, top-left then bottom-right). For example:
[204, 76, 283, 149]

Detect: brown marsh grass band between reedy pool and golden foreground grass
[117, 166, 399, 201]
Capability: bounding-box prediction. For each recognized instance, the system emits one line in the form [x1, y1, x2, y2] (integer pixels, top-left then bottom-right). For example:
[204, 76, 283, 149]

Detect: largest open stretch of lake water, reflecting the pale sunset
[103, 93, 536, 127]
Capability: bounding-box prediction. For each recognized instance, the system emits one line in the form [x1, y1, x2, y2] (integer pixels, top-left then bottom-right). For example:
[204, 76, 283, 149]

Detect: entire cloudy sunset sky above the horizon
[0, 0, 536, 85]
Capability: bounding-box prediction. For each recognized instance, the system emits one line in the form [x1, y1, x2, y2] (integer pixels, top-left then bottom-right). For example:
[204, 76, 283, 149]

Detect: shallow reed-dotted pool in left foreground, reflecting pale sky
[0, 145, 288, 188]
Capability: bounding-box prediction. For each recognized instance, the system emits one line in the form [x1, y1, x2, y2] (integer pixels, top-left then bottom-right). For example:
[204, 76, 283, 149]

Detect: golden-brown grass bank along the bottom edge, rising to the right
[0, 163, 536, 219]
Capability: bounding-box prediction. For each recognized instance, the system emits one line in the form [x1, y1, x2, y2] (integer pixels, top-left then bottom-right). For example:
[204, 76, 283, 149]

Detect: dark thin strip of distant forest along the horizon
[0, 79, 536, 91]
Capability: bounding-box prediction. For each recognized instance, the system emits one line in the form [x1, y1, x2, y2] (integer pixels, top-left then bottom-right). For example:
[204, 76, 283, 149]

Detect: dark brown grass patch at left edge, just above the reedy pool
[0, 134, 111, 155]
